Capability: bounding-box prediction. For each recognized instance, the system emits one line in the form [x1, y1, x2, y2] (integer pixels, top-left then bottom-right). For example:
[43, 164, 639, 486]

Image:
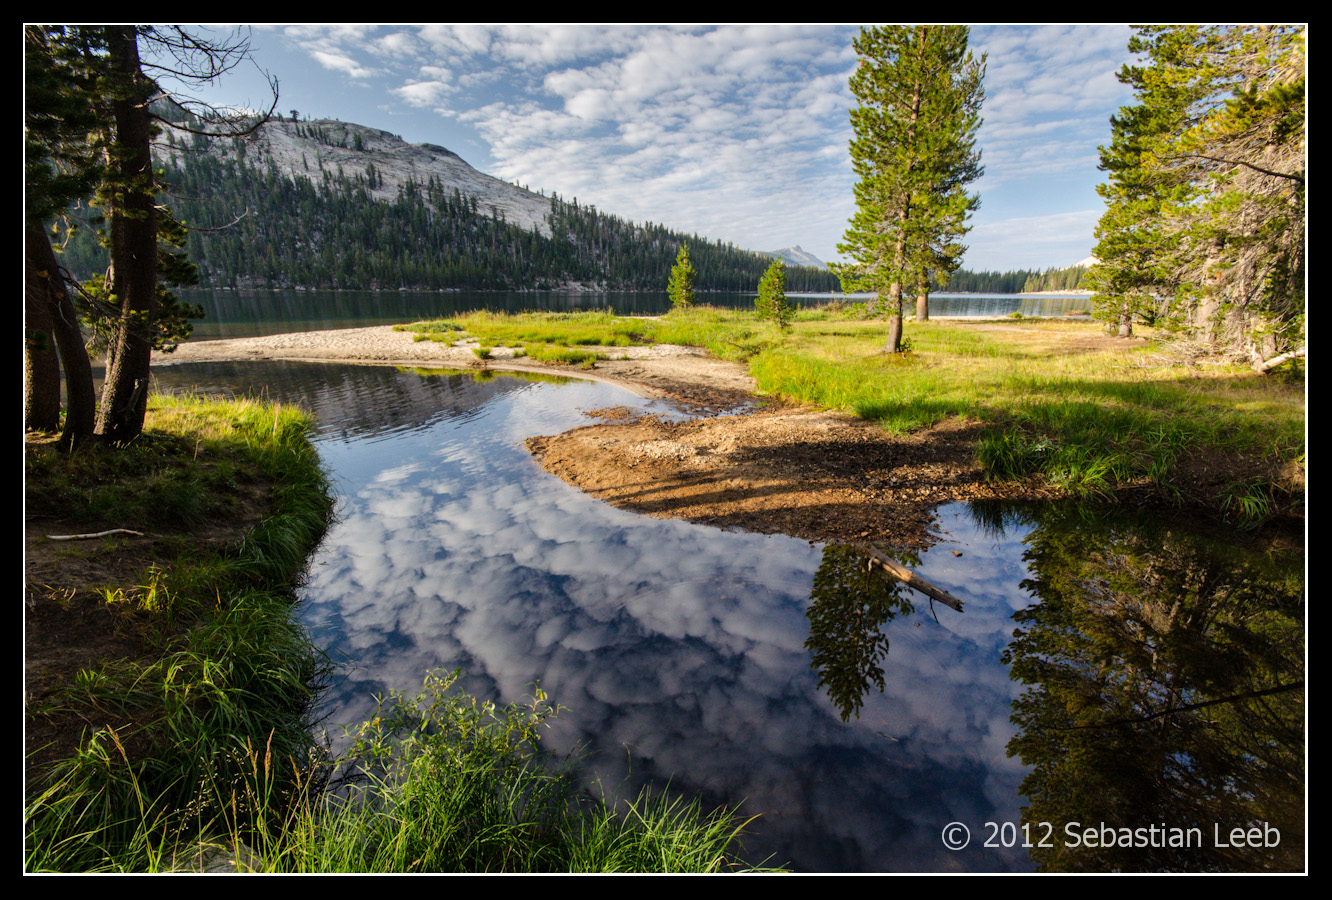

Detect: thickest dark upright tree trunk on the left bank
[97, 25, 157, 443]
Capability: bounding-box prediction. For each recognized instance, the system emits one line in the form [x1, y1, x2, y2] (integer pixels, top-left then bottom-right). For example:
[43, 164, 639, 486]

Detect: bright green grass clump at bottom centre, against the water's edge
[260, 672, 777, 872]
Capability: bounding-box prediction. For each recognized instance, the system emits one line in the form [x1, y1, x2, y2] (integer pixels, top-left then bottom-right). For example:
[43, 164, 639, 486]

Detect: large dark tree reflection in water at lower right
[974, 497, 1304, 871]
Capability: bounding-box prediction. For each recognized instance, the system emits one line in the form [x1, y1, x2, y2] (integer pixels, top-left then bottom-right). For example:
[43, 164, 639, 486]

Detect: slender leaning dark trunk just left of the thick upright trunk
[25, 225, 97, 453]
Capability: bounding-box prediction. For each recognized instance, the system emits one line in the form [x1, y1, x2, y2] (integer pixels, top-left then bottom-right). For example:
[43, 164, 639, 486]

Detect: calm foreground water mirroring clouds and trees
[157, 346, 1304, 872]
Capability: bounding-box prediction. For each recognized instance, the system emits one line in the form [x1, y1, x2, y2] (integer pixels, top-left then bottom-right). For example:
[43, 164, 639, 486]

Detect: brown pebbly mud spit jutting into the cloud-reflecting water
[527, 406, 1060, 547]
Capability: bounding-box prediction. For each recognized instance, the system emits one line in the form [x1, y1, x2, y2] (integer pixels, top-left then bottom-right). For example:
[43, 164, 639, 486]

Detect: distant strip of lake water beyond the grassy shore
[184, 290, 1088, 341]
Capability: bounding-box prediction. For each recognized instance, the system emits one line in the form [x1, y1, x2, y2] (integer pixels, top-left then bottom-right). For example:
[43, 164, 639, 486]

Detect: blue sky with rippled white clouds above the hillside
[151, 24, 1131, 272]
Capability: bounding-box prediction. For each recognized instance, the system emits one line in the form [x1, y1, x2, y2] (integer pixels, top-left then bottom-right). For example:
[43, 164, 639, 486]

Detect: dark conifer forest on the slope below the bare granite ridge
[59, 111, 838, 292]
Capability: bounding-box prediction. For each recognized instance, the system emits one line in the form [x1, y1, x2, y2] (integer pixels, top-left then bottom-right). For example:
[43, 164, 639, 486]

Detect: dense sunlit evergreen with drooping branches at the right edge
[1088, 25, 1307, 369]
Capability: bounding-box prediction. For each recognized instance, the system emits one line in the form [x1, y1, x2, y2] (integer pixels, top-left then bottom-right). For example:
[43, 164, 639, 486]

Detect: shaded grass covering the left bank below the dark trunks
[25, 398, 332, 871]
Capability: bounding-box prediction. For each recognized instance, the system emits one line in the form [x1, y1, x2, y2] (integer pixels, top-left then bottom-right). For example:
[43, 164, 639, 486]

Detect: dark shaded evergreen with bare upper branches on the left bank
[25, 25, 276, 446]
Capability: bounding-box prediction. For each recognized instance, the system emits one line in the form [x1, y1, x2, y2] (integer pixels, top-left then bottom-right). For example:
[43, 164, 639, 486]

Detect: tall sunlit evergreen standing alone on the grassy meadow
[834, 25, 984, 353]
